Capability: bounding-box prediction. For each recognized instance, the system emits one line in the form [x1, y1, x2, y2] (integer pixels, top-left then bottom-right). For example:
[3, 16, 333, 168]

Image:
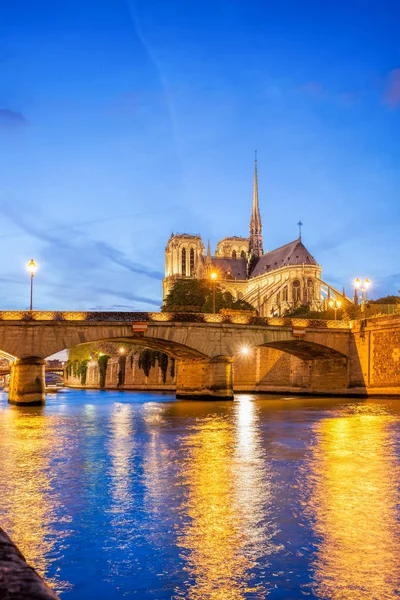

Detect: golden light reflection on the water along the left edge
[0, 408, 70, 591]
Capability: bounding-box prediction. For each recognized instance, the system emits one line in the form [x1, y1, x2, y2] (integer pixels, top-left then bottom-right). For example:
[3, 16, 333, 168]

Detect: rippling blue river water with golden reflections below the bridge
[0, 390, 400, 600]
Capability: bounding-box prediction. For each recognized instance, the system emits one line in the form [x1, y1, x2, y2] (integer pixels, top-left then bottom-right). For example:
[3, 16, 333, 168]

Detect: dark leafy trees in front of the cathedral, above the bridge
[162, 279, 254, 313]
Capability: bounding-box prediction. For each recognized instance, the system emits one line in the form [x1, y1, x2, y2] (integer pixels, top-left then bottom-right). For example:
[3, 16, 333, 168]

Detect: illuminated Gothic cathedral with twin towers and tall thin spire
[163, 158, 342, 317]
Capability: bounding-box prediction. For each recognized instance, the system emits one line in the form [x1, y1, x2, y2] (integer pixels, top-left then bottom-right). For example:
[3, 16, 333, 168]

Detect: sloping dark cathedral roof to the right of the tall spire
[251, 238, 318, 277]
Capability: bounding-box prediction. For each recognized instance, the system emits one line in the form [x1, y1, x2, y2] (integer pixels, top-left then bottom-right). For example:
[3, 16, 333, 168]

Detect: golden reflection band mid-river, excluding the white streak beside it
[177, 415, 266, 600]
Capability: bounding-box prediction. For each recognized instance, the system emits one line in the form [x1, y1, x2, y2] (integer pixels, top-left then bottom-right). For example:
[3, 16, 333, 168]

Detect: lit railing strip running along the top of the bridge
[0, 310, 350, 329]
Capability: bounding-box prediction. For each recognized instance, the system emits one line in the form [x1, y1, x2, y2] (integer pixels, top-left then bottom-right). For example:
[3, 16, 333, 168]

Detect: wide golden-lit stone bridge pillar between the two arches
[176, 356, 233, 400]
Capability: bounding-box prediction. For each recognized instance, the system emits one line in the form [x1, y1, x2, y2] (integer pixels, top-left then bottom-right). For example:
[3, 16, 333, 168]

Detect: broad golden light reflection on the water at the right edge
[310, 404, 400, 600]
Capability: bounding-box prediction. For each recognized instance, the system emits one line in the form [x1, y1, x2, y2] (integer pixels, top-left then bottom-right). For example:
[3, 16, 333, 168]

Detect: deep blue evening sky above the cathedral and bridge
[0, 0, 400, 310]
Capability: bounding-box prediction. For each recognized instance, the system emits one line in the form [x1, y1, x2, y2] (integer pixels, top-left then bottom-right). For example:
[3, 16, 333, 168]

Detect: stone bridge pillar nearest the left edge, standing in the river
[8, 356, 46, 406]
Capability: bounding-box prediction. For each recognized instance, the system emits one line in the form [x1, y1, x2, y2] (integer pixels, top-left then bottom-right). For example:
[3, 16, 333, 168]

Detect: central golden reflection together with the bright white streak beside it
[178, 399, 271, 600]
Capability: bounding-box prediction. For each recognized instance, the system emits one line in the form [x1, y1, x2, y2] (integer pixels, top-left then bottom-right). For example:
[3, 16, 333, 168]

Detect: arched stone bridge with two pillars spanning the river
[0, 311, 351, 404]
